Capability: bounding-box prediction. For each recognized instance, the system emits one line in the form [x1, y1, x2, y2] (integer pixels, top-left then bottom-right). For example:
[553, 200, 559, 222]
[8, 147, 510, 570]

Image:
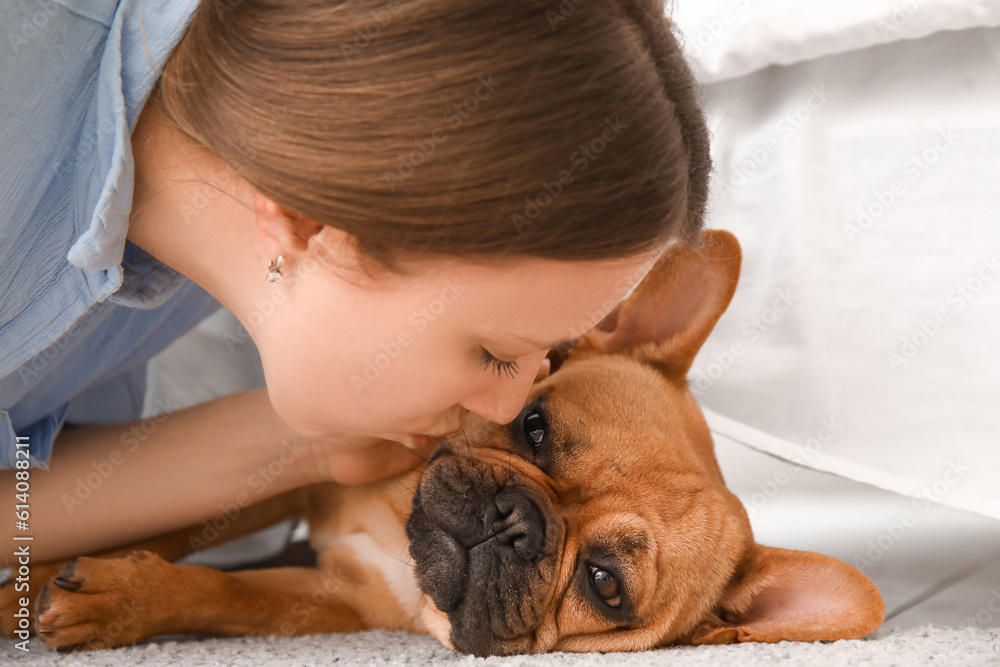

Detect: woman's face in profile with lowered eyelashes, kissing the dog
[253, 237, 659, 445]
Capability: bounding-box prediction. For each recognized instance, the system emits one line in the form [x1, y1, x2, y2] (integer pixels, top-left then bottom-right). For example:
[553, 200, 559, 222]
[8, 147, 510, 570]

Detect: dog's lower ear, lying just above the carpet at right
[688, 544, 885, 644]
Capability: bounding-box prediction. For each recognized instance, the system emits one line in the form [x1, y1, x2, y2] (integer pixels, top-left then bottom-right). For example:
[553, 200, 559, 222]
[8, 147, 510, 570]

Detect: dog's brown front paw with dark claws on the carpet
[35, 551, 158, 652]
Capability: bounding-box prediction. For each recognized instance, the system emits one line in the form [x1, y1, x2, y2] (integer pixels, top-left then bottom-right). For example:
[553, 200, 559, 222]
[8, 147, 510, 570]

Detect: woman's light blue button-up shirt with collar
[0, 0, 221, 468]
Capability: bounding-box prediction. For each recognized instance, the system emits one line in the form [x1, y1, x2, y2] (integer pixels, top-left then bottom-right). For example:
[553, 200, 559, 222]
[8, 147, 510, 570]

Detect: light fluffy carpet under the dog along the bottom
[0, 626, 1000, 667]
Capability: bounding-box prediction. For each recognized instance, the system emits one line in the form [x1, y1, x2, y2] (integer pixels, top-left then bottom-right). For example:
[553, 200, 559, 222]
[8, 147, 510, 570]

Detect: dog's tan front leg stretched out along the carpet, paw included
[36, 551, 365, 651]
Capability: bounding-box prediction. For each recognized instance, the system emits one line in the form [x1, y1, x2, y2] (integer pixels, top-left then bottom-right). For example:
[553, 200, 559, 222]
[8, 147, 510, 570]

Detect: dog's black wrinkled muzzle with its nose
[406, 459, 558, 656]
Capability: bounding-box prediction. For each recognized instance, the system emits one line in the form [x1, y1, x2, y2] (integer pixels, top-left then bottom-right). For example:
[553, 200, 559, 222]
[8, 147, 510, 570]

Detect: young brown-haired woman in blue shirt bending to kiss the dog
[0, 0, 710, 564]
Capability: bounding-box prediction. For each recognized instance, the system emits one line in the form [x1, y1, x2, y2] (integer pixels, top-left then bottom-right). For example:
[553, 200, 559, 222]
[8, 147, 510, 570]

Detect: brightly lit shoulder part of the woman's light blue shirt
[0, 0, 198, 376]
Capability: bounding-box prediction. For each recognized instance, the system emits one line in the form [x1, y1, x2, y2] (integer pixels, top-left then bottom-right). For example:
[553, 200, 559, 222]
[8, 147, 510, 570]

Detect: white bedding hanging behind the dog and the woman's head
[675, 0, 1000, 518]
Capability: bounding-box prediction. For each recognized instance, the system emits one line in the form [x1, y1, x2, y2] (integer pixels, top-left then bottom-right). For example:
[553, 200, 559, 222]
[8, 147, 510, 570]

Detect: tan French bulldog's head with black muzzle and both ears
[406, 231, 884, 655]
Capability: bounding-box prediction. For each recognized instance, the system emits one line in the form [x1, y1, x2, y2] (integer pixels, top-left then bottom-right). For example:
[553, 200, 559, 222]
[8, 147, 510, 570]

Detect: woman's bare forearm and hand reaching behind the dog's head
[0, 389, 430, 567]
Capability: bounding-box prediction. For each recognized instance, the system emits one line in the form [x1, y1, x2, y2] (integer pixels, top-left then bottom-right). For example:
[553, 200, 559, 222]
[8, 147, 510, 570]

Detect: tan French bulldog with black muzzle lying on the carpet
[0, 232, 884, 656]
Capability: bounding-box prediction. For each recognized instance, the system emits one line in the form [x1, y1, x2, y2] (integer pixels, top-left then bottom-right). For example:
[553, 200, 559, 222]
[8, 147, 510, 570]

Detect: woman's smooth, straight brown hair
[154, 0, 711, 280]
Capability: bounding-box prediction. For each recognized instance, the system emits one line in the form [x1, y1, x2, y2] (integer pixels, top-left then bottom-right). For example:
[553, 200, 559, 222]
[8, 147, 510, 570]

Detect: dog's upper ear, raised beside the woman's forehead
[576, 230, 742, 377]
